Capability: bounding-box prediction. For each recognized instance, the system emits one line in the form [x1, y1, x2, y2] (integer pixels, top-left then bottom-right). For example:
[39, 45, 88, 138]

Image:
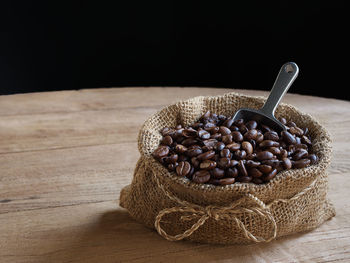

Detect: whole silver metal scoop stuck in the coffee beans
[233, 62, 299, 132]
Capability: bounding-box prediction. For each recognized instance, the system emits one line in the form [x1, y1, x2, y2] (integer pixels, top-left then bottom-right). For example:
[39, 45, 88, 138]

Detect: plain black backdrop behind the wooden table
[0, 0, 349, 99]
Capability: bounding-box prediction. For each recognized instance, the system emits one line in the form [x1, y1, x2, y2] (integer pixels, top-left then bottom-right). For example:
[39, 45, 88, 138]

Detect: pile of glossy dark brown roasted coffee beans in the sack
[153, 111, 318, 185]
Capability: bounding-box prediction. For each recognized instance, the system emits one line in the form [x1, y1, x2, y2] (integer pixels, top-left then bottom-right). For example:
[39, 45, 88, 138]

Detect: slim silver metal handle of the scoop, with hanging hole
[260, 62, 299, 116]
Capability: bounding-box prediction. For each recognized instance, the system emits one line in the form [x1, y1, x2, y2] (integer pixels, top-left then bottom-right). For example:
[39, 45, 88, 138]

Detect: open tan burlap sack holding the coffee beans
[120, 93, 335, 244]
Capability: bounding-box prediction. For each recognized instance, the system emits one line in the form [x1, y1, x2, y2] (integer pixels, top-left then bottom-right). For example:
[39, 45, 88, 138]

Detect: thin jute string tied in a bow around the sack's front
[154, 174, 316, 243]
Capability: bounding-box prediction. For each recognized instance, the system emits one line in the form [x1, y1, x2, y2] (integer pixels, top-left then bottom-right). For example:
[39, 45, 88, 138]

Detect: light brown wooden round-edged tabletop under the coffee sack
[0, 88, 350, 263]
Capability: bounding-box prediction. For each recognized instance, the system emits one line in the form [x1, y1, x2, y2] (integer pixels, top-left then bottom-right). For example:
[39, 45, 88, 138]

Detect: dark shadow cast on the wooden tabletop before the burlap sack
[42, 209, 308, 263]
